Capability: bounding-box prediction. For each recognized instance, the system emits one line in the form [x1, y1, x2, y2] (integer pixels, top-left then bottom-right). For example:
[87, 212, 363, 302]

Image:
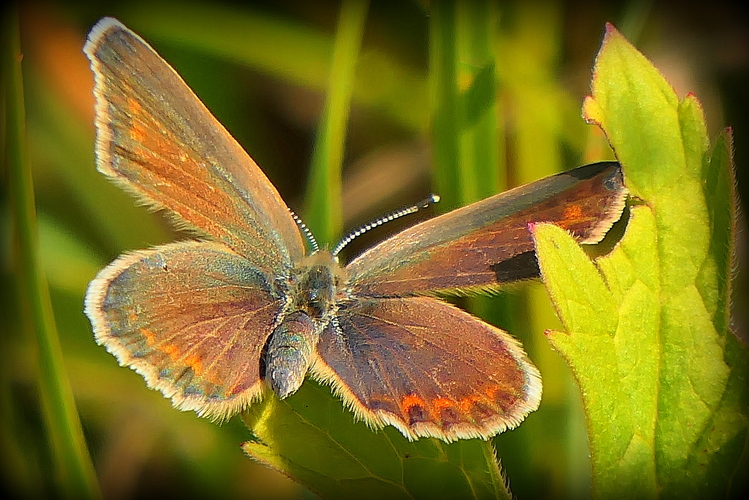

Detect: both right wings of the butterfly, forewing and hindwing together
[306, 162, 626, 441]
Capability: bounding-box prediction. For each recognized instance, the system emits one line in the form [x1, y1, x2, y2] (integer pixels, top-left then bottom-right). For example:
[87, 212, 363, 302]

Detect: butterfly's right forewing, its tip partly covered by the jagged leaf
[347, 162, 626, 297]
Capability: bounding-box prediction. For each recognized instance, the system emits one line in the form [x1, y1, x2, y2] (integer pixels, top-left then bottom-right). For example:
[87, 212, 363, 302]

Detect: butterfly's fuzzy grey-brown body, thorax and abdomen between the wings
[264, 252, 342, 398]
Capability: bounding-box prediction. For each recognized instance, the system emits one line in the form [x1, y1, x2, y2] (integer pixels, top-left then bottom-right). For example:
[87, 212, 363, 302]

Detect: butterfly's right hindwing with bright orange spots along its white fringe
[313, 297, 541, 441]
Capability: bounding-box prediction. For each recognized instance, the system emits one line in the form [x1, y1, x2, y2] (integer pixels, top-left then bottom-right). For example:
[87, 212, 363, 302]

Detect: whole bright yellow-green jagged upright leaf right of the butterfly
[535, 22, 749, 498]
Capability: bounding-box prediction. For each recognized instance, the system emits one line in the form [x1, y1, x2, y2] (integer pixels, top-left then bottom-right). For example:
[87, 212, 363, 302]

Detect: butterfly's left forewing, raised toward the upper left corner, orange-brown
[84, 19, 304, 272]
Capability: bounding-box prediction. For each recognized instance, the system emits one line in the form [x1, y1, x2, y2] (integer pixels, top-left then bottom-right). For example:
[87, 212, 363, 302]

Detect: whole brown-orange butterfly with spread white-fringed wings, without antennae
[84, 18, 626, 442]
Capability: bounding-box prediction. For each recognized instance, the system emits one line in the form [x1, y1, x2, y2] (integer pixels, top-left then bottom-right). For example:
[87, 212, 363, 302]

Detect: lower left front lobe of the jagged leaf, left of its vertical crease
[535, 213, 658, 498]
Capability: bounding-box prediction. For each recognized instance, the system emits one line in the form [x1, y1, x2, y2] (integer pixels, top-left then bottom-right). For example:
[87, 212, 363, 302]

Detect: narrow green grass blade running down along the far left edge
[3, 7, 101, 498]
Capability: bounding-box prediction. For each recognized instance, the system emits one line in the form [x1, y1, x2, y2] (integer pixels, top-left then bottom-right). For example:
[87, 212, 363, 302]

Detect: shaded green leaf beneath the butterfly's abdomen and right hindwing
[243, 380, 508, 499]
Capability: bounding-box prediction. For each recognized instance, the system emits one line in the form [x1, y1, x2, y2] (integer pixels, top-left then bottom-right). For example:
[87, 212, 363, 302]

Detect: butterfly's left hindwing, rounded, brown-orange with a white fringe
[86, 242, 284, 418]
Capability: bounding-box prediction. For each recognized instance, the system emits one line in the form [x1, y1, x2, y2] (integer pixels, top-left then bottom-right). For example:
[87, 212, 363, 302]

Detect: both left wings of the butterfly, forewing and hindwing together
[84, 18, 304, 419]
